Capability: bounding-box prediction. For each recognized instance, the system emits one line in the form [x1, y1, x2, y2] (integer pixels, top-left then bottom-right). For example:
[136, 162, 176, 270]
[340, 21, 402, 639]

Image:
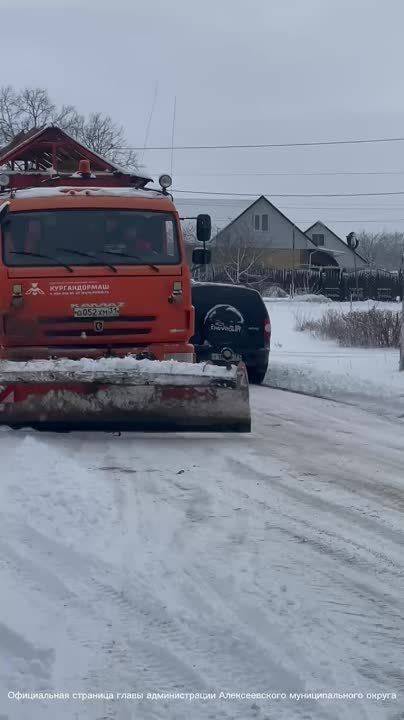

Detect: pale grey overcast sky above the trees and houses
[0, 0, 404, 235]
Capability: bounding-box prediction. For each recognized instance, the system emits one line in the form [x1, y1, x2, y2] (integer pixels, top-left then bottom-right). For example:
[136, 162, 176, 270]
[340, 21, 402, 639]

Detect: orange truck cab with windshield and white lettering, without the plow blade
[0, 182, 202, 361]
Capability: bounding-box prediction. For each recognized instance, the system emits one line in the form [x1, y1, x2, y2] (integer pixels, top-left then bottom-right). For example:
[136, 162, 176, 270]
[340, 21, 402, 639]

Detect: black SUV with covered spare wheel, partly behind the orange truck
[191, 282, 271, 383]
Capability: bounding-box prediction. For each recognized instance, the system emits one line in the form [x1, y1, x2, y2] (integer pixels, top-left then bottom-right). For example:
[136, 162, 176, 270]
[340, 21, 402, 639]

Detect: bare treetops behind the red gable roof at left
[0, 85, 137, 169]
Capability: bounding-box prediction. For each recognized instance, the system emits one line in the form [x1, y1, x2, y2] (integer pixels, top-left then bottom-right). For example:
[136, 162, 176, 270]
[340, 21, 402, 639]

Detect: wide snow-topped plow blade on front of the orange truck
[0, 358, 251, 432]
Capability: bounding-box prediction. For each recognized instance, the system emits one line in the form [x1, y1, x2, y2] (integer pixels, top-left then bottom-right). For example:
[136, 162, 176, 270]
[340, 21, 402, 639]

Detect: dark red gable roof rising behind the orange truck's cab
[0, 125, 150, 184]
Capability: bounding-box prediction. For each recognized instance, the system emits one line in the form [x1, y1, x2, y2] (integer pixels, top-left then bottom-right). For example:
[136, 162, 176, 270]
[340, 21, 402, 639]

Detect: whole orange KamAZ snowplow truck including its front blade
[0, 161, 250, 431]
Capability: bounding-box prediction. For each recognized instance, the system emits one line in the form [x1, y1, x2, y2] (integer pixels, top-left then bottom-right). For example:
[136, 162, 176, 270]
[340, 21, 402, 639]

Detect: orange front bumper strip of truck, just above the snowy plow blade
[0, 343, 194, 362]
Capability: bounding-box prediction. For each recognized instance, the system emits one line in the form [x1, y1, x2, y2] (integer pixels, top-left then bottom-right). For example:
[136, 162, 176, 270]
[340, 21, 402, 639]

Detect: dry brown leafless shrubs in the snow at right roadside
[295, 308, 401, 348]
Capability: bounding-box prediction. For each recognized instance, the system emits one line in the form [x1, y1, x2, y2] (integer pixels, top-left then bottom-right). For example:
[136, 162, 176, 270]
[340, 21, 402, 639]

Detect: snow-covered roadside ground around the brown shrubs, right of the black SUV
[266, 299, 404, 413]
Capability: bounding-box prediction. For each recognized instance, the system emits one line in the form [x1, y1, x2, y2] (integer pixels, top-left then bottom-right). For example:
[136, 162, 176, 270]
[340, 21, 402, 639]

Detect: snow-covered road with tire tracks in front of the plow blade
[0, 387, 404, 720]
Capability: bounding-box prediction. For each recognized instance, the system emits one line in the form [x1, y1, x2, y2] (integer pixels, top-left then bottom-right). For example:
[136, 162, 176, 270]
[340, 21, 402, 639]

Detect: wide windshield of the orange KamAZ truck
[2, 210, 180, 268]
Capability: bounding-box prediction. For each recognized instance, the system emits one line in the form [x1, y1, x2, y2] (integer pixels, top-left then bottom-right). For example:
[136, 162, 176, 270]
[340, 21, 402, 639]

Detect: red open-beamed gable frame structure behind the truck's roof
[0, 126, 151, 190]
